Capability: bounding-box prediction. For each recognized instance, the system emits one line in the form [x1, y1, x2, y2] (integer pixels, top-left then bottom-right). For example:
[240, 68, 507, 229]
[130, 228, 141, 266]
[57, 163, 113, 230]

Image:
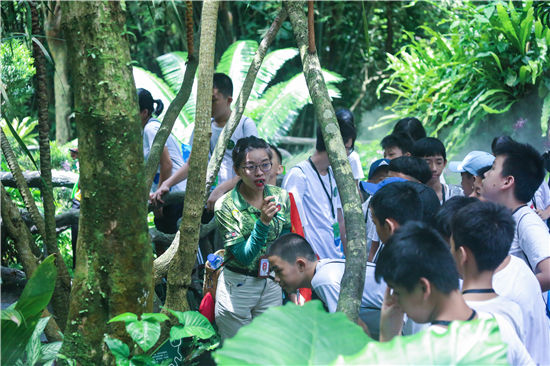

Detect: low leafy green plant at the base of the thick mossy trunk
[105, 310, 219, 365]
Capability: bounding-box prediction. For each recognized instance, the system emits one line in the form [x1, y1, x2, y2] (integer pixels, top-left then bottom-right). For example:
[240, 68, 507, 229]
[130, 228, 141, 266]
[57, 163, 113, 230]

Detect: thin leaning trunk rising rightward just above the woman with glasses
[204, 9, 287, 193]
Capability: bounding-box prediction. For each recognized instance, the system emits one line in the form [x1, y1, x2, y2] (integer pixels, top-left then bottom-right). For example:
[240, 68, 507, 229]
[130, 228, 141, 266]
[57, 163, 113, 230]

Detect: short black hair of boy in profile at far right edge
[495, 140, 545, 203]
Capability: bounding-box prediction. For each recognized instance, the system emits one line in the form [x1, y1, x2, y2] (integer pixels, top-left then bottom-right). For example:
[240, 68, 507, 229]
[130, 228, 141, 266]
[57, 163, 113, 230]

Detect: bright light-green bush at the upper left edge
[0, 38, 36, 118]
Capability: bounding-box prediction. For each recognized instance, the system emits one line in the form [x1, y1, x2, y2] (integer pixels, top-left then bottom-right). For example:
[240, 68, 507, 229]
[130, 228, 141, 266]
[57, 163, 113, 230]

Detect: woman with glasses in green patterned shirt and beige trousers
[214, 136, 290, 340]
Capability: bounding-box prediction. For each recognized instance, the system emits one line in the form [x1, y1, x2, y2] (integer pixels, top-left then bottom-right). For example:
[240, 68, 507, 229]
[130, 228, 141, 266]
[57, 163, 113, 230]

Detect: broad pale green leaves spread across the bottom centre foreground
[214, 301, 507, 366]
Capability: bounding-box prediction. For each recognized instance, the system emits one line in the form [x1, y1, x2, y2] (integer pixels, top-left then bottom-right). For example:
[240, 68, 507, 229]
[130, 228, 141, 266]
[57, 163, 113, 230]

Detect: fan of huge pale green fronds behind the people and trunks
[147, 40, 343, 142]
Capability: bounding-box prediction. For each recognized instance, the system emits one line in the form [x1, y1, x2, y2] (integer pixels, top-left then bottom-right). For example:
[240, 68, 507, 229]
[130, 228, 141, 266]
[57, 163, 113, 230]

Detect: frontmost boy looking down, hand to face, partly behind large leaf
[375, 222, 534, 365]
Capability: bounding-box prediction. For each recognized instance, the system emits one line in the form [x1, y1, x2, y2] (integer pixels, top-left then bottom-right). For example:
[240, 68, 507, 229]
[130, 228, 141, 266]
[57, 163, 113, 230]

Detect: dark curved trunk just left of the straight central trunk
[145, 55, 197, 189]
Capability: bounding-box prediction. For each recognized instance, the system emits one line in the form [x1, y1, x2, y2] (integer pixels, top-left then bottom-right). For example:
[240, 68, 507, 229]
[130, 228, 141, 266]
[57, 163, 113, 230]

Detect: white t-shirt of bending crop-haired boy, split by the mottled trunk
[311, 259, 386, 339]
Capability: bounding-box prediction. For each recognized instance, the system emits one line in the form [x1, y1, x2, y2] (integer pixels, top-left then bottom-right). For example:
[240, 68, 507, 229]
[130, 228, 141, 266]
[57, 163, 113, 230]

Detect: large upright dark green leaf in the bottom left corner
[1, 255, 57, 365]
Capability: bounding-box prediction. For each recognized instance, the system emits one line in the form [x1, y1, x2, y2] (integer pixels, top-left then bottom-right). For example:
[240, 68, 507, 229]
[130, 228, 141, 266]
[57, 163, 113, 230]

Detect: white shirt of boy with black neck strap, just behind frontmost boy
[465, 296, 525, 344]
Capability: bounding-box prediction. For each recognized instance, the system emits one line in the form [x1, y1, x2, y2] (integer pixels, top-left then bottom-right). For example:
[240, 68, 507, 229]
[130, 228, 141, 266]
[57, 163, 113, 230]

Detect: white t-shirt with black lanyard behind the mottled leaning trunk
[283, 160, 344, 259]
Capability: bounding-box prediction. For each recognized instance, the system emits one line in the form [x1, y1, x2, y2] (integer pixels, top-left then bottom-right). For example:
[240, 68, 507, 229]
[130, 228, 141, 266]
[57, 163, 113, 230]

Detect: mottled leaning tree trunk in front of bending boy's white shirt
[284, 1, 367, 322]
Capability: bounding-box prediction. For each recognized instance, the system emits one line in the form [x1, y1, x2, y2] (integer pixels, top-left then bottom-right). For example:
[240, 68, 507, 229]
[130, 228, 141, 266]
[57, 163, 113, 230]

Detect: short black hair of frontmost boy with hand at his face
[374, 221, 458, 294]
